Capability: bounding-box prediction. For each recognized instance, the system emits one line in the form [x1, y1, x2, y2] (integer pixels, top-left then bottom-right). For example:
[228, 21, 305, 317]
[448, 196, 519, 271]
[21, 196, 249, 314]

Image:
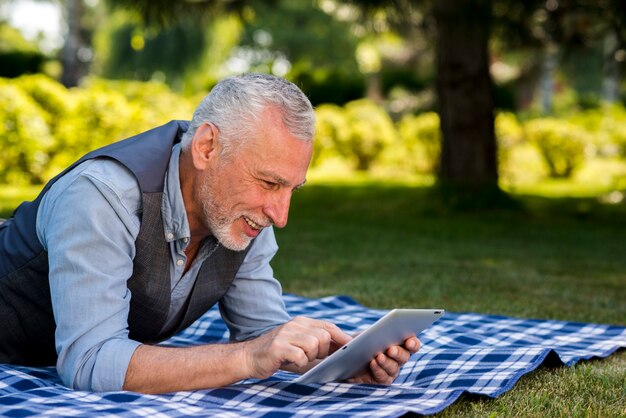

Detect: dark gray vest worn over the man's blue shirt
[0, 121, 249, 365]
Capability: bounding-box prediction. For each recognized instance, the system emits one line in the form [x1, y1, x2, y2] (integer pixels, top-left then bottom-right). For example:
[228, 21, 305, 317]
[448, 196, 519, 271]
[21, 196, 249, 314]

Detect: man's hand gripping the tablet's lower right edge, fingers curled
[348, 337, 420, 385]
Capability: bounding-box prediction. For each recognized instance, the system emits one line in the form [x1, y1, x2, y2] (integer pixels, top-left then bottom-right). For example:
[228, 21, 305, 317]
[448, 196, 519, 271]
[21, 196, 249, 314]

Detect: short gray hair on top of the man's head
[181, 73, 315, 153]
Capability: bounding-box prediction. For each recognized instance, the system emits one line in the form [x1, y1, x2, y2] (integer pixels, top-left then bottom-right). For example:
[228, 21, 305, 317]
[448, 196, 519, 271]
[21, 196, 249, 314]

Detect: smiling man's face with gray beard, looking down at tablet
[199, 112, 312, 251]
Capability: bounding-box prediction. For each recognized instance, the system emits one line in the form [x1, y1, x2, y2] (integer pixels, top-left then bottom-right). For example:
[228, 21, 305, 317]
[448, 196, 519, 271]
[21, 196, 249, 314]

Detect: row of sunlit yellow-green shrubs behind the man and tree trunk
[6, 75, 626, 187]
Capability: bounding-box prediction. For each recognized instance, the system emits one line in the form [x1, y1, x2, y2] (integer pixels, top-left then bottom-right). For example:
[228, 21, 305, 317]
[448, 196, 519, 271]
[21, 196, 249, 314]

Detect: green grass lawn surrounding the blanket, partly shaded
[0, 178, 626, 417]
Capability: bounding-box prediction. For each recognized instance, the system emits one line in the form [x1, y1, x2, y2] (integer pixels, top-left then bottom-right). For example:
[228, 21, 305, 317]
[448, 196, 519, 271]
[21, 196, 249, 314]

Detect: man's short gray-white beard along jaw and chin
[199, 179, 252, 251]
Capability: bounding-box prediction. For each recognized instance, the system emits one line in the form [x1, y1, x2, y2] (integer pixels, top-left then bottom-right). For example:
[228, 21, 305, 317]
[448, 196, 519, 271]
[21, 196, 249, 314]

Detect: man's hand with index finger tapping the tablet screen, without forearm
[245, 316, 354, 379]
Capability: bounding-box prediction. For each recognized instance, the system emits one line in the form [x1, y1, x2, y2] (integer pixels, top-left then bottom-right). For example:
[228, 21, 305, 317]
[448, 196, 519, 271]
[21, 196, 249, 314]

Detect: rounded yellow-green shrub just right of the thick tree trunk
[524, 118, 588, 178]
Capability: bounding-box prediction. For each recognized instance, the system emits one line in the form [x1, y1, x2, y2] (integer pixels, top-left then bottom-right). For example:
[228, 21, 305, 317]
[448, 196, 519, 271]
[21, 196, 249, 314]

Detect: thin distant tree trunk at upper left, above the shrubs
[61, 0, 82, 87]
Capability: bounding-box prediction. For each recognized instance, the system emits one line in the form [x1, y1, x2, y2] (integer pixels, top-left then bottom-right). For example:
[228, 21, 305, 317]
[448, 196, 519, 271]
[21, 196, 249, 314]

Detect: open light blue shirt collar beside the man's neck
[161, 143, 191, 242]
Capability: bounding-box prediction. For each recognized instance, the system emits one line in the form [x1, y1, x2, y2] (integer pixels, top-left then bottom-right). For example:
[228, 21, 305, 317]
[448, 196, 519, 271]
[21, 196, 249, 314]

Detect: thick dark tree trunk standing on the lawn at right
[434, 0, 498, 191]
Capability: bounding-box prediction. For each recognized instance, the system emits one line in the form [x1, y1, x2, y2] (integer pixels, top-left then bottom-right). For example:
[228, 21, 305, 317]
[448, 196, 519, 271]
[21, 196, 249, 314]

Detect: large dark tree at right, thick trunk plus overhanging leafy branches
[344, 0, 626, 198]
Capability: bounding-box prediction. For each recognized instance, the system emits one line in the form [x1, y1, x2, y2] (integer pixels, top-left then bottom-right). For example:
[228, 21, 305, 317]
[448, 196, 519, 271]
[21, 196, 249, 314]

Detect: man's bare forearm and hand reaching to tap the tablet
[119, 317, 352, 393]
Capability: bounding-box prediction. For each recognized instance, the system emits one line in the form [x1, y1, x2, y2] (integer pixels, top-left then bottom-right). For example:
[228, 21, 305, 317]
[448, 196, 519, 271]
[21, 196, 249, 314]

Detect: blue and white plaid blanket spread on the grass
[0, 295, 626, 417]
